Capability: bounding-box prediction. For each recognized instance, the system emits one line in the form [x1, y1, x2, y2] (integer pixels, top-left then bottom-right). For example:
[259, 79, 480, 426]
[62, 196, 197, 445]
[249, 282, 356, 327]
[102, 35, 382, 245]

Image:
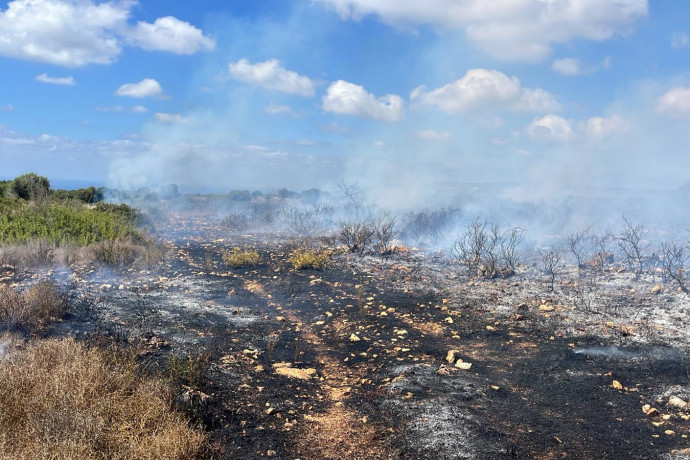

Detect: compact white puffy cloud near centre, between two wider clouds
[322, 80, 405, 121]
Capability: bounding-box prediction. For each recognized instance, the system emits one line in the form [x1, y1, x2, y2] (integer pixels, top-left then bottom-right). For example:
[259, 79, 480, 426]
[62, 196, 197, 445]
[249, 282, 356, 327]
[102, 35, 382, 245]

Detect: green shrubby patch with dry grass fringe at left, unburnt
[0, 174, 164, 267]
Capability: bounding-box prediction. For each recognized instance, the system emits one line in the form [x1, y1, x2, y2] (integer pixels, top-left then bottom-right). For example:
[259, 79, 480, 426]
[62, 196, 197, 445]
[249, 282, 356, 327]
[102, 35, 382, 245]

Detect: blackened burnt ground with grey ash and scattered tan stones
[4, 222, 690, 459]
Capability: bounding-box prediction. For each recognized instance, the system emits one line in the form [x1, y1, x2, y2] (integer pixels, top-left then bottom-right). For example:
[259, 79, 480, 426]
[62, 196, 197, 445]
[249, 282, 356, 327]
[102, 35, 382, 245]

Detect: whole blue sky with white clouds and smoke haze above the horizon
[0, 0, 690, 200]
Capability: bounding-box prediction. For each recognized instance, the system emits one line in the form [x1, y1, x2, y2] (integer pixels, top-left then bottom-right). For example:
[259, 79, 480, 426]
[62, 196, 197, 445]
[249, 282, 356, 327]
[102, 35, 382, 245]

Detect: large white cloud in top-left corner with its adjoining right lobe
[0, 0, 215, 67]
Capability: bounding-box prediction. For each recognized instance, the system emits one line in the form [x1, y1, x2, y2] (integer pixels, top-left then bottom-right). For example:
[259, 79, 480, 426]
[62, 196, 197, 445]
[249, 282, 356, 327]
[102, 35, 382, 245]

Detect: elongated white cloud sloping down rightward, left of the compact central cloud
[228, 59, 314, 97]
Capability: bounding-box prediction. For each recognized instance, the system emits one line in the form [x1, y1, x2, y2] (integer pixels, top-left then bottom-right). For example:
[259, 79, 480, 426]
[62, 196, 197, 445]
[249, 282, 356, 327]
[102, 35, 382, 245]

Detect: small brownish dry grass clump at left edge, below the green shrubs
[0, 281, 68, 331]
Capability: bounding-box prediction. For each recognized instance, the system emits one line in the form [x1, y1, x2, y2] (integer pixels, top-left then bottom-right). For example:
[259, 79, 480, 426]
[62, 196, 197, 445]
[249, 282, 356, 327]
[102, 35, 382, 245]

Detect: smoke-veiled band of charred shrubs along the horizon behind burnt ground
[105, 181, 690, 292]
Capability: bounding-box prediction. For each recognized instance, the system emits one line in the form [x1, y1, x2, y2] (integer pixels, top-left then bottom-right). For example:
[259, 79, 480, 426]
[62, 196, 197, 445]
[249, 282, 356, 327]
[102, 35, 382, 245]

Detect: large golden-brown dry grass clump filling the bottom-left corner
[0, 339, 205, 459]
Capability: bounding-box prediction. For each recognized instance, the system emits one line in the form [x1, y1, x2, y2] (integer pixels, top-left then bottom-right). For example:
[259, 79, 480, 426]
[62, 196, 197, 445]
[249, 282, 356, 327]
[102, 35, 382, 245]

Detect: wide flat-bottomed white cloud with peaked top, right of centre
[410, 69, 559, 113]
